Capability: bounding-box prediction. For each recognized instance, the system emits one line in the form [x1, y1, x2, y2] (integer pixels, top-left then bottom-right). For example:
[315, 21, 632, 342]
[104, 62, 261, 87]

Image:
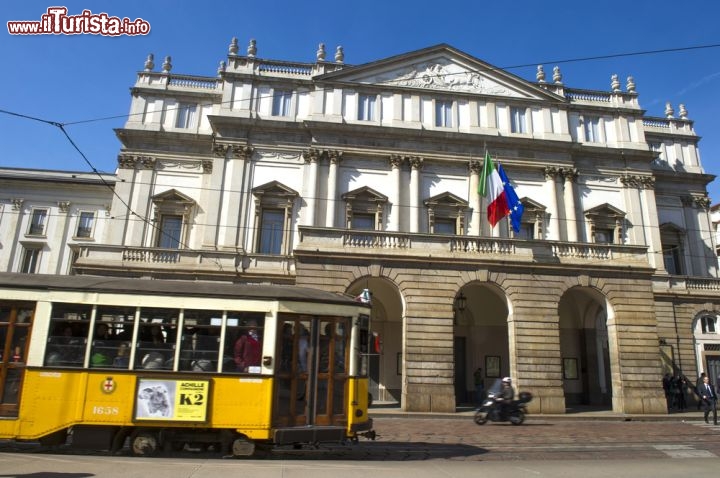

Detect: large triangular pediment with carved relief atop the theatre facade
[315, 44, 560, 100]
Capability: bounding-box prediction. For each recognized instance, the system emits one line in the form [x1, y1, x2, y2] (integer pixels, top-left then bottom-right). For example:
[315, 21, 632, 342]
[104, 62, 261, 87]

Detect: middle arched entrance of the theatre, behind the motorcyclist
[453, 282, 511, 405]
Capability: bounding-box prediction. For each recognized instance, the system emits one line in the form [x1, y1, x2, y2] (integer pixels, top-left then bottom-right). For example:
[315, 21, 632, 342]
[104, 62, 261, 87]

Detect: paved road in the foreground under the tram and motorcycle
[0, 417, 720, 478]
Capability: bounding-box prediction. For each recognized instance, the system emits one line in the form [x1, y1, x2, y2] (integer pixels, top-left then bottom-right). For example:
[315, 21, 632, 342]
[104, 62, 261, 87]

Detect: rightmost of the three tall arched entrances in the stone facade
[558, 287, 613, 410]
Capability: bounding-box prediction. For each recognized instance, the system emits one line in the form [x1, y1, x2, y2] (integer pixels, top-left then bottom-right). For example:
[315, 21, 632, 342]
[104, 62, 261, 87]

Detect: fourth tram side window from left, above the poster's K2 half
[180, 309, 222, 372]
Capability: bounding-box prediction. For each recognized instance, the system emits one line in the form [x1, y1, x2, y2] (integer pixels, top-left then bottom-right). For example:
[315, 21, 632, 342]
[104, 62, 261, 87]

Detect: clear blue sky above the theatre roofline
[0, 0, 720, 200]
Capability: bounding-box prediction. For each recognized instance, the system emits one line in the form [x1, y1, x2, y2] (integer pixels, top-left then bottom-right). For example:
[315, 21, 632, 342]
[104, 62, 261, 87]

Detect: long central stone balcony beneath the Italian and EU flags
[295, 227, 651, 271]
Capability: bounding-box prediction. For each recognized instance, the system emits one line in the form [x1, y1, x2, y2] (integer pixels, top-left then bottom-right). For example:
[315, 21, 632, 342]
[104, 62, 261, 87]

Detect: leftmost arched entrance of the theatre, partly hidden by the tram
[348, 277, 405, 403]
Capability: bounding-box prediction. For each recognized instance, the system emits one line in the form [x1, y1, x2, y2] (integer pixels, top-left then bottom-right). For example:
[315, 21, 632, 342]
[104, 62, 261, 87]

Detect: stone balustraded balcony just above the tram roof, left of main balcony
[72, 244, 295, 284]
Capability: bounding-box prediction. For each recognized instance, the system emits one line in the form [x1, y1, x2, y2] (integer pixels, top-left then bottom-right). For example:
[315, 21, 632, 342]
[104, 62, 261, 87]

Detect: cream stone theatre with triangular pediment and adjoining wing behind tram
[0, 39, 720, 413]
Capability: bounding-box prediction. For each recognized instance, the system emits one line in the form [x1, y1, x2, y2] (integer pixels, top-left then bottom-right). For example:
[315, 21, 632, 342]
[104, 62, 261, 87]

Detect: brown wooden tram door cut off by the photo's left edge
[0, 301, 34, 417]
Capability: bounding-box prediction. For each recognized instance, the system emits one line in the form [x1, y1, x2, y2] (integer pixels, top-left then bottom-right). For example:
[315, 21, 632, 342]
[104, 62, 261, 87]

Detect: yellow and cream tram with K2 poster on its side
[0, 273, 374, 456]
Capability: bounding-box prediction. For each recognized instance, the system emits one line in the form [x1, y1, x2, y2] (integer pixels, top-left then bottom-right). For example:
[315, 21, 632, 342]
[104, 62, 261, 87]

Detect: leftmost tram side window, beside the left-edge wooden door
[45, 302, 92, 367]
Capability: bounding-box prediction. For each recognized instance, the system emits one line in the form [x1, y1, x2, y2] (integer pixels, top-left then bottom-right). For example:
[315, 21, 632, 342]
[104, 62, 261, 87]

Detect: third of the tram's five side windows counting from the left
[135, 308, 180, 370]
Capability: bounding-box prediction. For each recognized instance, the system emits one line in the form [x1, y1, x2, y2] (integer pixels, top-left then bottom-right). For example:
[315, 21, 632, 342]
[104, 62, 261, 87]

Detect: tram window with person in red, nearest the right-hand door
[223, 312, 265, 373]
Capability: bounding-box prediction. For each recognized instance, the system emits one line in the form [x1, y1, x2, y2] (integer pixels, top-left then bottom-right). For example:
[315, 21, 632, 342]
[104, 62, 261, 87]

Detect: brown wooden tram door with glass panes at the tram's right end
[273, 317, 350, 426]
